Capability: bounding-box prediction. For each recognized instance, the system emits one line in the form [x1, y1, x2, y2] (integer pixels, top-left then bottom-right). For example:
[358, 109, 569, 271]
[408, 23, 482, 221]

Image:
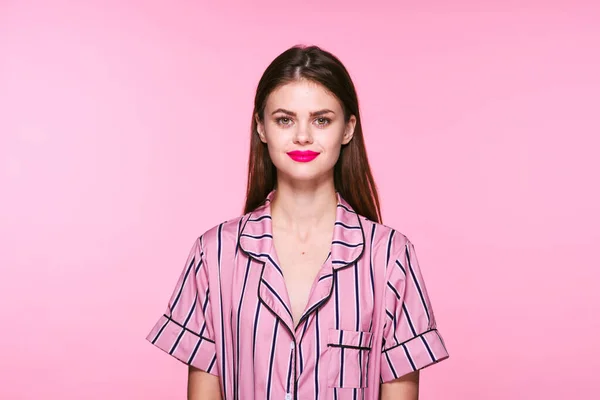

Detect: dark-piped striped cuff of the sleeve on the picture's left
[146, 315, 218, 375]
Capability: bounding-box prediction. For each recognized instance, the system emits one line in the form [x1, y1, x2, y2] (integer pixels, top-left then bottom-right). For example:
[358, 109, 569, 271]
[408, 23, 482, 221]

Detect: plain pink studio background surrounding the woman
[0, 0, 600, 400]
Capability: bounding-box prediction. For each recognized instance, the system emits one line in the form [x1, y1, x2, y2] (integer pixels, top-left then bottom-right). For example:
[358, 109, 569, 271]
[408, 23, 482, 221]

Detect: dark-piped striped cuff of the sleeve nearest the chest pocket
[381, 329, 448, 383]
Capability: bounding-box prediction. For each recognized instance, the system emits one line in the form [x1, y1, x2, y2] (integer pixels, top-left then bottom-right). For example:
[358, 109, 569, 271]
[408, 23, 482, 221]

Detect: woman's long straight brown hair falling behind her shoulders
[244, 45, 381, 222]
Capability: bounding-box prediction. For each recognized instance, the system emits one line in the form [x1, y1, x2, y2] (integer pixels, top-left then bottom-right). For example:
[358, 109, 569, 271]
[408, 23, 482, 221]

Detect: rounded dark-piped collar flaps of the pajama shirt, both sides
[239, 190, 365, 269]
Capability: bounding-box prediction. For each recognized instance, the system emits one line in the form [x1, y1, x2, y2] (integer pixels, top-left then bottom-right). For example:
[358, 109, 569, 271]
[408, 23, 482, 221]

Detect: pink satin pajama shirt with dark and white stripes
[147, 192, 448, 400]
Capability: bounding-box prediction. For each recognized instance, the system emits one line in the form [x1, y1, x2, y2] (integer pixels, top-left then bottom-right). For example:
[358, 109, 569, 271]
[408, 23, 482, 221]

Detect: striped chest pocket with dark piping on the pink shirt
[327, 329, 372, 388]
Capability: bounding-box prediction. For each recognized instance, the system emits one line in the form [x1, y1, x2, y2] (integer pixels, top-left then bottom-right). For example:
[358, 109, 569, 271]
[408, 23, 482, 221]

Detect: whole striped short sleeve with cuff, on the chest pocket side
[381, 240, 448, 383]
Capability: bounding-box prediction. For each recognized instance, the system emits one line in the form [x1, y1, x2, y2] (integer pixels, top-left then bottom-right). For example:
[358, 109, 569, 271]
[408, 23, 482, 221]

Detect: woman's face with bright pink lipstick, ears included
[257, 80, 356, 186]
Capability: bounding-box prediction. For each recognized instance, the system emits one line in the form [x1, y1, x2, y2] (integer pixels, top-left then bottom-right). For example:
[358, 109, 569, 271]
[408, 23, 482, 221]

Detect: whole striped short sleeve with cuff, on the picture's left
[146, 238, 218, 375]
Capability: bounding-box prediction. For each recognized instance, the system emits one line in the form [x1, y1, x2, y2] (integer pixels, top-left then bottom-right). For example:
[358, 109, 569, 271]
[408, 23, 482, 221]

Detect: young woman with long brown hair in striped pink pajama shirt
[147, 46, 448, 400]
